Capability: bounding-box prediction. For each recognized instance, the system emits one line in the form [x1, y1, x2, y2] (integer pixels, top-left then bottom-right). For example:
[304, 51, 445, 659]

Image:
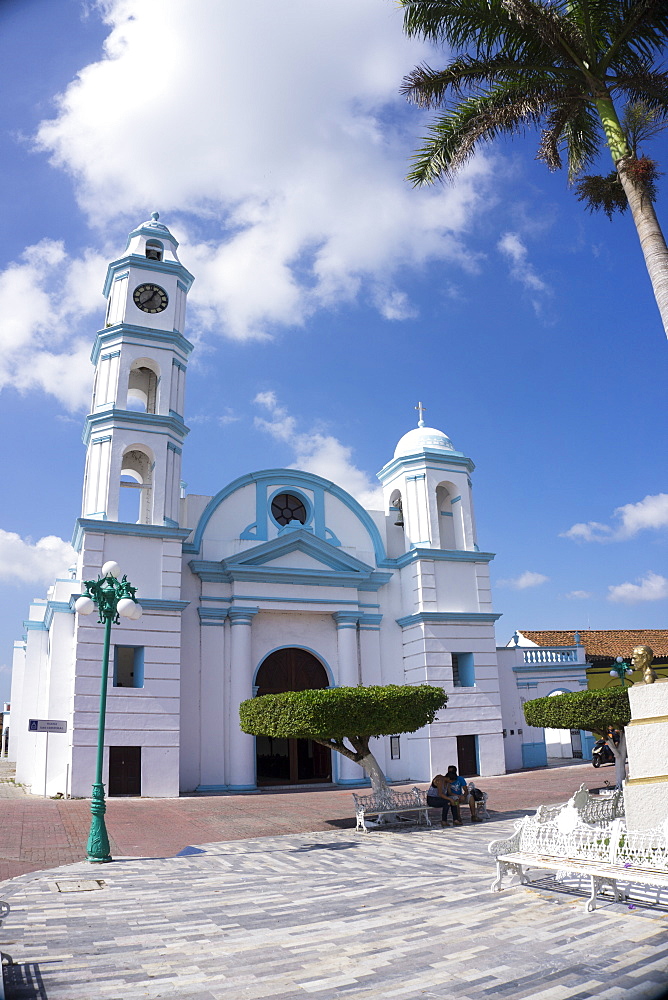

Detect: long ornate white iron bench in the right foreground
[488, 806, 668, 912]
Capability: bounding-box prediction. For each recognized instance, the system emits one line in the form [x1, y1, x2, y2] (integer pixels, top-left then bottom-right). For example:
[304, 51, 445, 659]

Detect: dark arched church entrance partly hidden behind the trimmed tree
[255, 648, 332, 785]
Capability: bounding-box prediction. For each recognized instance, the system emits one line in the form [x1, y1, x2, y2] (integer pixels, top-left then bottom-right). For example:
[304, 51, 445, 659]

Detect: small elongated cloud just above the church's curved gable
[253, 392, 383, 510]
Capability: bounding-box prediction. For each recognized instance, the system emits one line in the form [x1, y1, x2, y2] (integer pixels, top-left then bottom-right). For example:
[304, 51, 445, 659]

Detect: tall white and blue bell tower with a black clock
[81, 212, 194, 527]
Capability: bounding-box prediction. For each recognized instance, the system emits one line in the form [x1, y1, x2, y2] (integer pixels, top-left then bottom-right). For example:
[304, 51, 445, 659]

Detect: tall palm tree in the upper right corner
[399, 0, 668, 336]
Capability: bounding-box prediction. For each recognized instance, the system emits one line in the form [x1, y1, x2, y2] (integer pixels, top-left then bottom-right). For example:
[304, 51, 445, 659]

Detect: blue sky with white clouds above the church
[0, 0, 668, 701]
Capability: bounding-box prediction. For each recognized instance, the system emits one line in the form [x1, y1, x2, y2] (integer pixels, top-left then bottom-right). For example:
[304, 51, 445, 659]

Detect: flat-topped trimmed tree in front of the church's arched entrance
[239, 684, 448, 792]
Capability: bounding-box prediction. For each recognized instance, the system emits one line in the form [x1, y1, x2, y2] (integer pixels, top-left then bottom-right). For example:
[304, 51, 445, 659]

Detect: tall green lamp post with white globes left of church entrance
[74, 562, 142, 862]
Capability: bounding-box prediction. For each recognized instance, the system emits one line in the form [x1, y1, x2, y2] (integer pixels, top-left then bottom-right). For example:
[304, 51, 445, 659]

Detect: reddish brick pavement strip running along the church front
[0, 761, 614, 882]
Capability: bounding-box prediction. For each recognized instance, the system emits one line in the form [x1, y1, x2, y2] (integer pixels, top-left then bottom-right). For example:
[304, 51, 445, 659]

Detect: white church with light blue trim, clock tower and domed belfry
[11, 213, 504, 796]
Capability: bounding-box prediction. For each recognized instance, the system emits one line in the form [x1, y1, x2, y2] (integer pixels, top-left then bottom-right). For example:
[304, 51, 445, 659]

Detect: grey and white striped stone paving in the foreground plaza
[1, 820, 668, 1000]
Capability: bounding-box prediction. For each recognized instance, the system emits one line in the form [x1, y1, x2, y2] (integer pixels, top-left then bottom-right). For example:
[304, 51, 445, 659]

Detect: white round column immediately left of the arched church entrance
[227, 608, 259, 790]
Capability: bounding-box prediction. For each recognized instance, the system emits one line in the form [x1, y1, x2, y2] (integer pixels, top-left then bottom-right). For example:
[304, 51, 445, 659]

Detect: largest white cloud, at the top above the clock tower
[32, 0, 488, 338]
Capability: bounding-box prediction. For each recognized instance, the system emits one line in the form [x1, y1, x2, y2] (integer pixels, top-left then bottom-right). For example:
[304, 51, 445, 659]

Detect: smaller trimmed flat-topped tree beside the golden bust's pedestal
[524, 687, 631, 788]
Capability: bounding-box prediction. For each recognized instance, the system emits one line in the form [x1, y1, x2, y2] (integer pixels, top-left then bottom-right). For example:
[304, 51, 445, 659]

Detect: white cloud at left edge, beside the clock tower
[0, 239, 105, 410]
